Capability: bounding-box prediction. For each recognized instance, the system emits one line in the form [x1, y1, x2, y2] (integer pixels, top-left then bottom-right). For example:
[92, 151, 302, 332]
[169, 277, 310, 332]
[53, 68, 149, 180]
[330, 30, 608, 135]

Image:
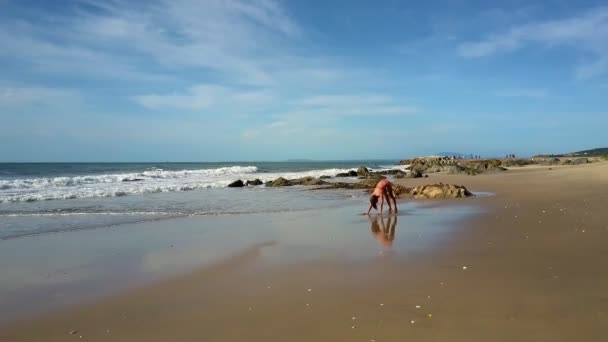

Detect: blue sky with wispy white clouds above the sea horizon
[0, 0, 608, 162]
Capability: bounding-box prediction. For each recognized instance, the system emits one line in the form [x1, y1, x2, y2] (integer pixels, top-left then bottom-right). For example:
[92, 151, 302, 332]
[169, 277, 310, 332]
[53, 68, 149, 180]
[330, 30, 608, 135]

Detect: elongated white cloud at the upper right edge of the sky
[458, 7, 608, 78]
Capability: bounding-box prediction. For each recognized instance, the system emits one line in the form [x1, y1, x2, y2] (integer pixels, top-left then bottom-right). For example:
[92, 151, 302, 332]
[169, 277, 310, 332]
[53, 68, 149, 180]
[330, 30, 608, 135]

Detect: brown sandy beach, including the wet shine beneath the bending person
[0, 162, 608, 341]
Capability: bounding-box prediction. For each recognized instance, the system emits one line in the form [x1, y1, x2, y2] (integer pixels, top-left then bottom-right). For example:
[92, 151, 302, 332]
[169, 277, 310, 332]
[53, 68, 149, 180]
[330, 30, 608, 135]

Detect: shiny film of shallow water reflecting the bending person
[0, 202, 476, 322]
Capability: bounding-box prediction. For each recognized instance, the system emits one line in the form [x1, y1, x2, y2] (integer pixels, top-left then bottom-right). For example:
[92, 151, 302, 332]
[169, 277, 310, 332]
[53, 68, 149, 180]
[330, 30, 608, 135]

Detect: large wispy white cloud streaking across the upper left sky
[0, 0, 301, 84]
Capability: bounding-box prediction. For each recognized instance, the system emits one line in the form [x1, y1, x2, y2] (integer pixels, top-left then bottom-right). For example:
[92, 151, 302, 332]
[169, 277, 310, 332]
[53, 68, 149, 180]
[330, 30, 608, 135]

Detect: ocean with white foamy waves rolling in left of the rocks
[0, 160, 406, 240]
